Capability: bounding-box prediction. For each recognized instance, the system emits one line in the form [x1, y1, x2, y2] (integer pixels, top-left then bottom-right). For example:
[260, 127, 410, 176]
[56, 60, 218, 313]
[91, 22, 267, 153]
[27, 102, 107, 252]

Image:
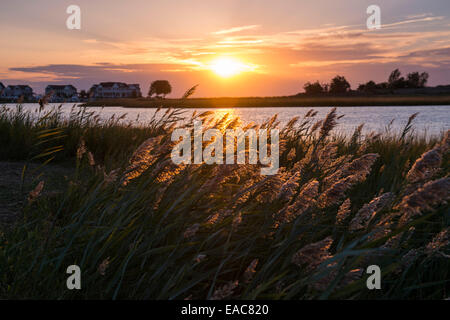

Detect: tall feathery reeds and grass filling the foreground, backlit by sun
[0, 105, 450, 299]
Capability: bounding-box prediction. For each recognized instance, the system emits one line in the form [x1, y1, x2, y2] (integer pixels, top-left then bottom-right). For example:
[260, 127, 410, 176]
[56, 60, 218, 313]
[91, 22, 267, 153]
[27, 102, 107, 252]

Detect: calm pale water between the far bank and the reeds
[7, 103, 450, 137]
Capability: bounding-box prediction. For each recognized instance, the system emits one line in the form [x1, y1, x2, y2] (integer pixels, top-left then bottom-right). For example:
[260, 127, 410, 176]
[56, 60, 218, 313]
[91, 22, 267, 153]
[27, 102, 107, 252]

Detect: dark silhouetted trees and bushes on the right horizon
[303, 69, 429, 95]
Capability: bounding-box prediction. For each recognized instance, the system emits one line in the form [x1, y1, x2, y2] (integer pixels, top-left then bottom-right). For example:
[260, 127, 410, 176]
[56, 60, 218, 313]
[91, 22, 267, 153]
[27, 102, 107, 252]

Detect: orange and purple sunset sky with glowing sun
[0, 0, 450, 97]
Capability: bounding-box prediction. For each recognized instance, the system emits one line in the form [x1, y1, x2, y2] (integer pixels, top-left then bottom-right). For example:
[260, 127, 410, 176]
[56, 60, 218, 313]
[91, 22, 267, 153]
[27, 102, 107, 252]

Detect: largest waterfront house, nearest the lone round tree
[89, 82, 142, 99]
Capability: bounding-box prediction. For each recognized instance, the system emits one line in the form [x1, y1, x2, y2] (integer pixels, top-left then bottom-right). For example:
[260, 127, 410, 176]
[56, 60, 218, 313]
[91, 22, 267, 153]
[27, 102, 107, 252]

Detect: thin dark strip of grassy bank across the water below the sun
[81, 95, 450, 108]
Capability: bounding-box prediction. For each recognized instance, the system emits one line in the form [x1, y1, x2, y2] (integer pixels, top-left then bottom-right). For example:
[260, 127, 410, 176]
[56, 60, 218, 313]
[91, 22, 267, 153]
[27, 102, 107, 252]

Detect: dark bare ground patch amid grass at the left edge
[0, 162, 71, 226]
